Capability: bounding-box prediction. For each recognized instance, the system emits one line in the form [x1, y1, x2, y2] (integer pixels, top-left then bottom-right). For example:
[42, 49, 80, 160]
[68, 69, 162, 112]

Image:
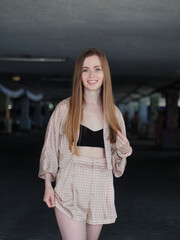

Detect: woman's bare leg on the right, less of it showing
[86, 223, 103, 240]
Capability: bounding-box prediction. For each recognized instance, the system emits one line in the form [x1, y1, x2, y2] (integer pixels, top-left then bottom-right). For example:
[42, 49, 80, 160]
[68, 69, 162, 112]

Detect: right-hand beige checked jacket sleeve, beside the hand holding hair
[111, 106, 132, 178]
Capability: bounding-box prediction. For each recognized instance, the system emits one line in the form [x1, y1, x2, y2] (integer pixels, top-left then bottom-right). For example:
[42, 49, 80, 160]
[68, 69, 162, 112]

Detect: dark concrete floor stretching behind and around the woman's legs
[0, 130, 180, 240]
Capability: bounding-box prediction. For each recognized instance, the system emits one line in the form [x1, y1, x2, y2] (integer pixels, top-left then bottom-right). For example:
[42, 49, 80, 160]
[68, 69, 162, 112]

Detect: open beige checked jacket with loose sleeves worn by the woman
[38, 98, 132, 181]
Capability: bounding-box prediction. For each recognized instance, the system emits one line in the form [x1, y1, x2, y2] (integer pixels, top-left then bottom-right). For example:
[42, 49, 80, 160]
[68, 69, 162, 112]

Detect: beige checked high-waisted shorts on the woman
[54, 155, 117, 224]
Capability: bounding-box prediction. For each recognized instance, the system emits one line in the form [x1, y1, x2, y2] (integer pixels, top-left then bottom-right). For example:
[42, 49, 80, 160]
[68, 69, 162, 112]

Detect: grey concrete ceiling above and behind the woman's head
[0, 0, 180, 102]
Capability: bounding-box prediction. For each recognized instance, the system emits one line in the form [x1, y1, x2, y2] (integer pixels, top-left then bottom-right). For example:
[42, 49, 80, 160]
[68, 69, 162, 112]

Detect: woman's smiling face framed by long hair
[81, 55, 104, 91]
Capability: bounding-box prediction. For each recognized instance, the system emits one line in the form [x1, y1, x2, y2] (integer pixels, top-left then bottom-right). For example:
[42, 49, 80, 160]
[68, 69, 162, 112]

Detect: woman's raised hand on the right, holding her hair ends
[116, 130, 131, 154]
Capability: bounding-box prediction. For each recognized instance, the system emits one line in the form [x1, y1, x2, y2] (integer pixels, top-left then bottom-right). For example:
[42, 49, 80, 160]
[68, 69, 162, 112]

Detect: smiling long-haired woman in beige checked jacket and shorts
[38, 48, 132, 240]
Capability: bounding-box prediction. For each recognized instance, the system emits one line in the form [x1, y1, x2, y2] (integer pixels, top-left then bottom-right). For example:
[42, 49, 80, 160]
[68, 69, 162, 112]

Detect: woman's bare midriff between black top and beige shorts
[77, 146, 105, 158]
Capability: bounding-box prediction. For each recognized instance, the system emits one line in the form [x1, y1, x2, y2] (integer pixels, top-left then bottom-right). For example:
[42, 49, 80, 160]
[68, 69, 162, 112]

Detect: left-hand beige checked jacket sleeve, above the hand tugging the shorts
[38, 107, 62, 181]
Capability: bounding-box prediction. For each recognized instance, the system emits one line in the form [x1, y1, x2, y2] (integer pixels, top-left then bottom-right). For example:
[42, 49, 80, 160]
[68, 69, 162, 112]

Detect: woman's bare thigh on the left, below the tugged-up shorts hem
[54, 207, 86, 240]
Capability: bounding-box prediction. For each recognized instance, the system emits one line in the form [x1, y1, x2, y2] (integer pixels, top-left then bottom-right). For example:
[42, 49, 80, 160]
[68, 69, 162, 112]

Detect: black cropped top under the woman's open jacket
[77, 125, 104, 148]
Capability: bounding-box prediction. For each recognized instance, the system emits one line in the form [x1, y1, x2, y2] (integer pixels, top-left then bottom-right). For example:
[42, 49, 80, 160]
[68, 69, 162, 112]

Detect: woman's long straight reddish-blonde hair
[64, 48, 121, 155]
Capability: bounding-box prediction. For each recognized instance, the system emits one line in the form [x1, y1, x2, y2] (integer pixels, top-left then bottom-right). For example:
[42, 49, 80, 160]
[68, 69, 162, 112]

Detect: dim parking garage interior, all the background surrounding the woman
[0, 0, 180, 240]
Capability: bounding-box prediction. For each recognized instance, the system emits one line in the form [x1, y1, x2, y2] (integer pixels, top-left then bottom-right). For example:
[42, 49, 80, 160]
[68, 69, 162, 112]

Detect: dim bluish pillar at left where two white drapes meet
[20, 97, 31, 130]
